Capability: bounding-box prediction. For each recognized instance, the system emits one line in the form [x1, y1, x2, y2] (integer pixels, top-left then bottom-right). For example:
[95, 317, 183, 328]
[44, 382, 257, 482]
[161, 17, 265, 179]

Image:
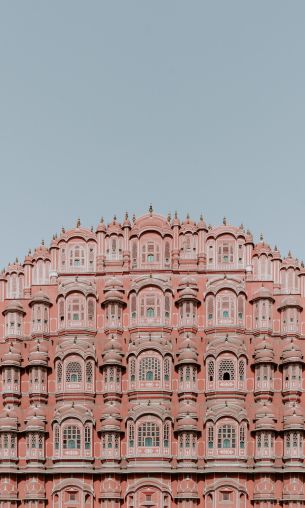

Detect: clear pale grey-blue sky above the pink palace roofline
[0, 0, 305, 266]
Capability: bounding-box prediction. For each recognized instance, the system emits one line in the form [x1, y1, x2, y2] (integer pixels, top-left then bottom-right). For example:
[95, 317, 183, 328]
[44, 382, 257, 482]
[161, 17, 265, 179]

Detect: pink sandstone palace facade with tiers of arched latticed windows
[0, 209, 305, 508]
